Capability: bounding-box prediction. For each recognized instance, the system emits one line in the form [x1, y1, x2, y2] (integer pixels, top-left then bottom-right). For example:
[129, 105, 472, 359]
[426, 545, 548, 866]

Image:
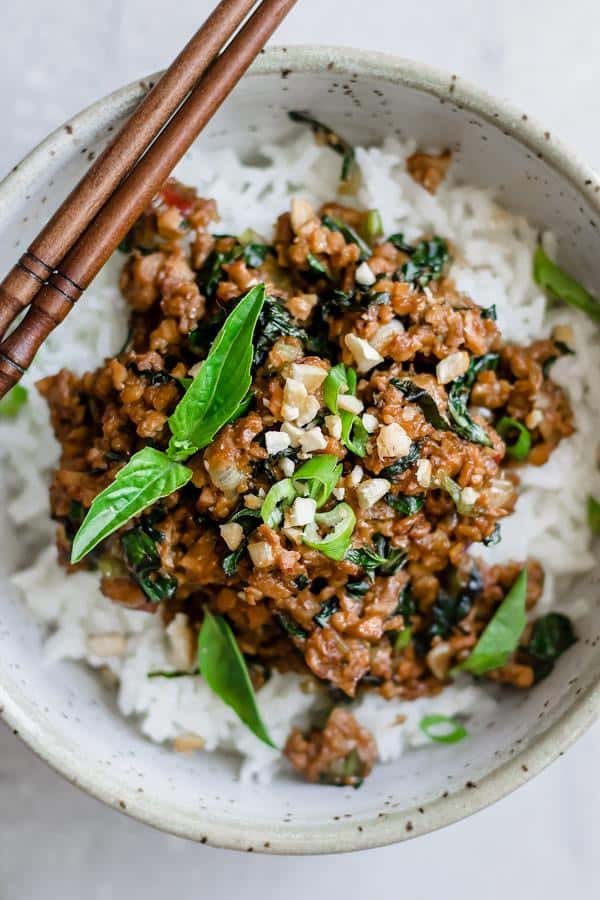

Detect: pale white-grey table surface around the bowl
[0, 0, 600, 900]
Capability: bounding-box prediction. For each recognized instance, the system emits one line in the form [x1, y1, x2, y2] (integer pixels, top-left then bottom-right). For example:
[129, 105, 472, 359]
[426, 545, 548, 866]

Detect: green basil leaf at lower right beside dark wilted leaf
[456, 569, 527, 675]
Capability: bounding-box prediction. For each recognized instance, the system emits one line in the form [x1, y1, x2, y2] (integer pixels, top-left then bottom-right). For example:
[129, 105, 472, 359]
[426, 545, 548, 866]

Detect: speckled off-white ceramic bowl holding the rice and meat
[0, 47, 600, 853]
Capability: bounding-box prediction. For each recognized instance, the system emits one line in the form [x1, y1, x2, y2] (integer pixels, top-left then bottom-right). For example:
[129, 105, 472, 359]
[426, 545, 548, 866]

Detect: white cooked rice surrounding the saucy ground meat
[0, 135, 600, 781]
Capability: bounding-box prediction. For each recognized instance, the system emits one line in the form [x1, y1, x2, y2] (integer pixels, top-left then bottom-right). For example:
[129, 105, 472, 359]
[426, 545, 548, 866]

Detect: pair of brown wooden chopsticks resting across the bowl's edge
[0, 0, 296, 398]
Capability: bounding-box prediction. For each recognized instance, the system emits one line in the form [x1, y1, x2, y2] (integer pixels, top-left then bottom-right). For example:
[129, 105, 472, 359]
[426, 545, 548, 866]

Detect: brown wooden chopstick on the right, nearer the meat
[0, 0, 296, 398]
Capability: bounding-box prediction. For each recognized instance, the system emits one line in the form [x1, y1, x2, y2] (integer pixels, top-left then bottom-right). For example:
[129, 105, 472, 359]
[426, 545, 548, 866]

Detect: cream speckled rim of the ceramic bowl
[0, 44, 600, 855]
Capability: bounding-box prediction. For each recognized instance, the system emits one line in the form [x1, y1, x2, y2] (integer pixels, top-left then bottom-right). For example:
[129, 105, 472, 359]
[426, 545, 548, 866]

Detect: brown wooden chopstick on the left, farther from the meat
[0, 0, 257, 339]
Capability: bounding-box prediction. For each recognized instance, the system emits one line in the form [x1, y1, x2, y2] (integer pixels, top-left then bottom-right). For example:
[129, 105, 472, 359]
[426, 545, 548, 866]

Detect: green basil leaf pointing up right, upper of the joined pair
[169, 284, 265, 456]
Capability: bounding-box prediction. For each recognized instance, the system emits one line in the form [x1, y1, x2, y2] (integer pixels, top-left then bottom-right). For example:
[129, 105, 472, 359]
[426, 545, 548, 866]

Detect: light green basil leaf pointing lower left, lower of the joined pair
[71, 447, 193, 563]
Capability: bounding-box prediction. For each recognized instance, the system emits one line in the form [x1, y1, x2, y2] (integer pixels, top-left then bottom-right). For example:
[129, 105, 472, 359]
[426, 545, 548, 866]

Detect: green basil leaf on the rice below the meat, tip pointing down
[198, 610, 276, 749]
